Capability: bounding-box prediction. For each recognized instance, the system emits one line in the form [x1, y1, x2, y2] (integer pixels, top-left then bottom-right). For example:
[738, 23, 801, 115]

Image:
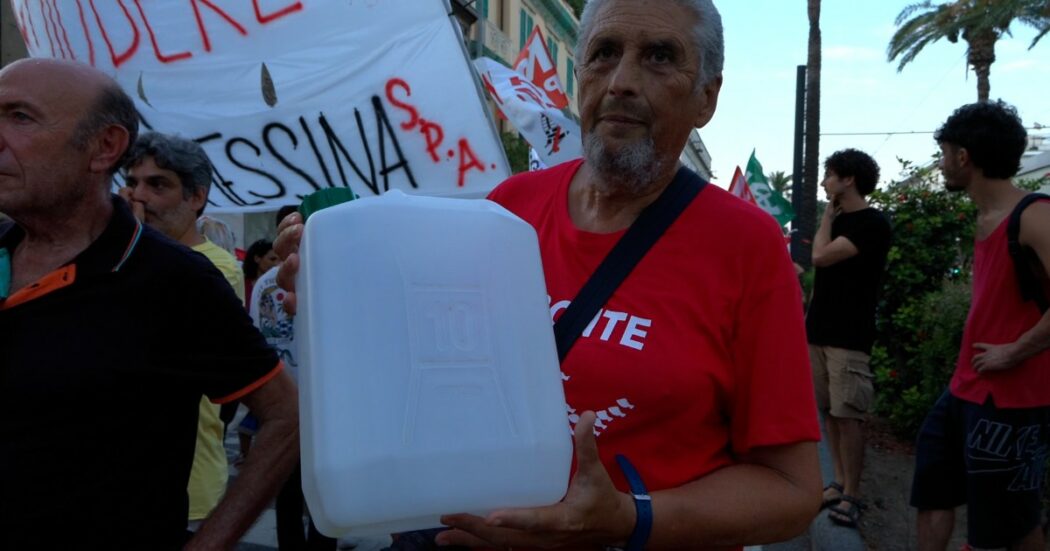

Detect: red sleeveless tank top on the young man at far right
[950, 199, 1050, 407]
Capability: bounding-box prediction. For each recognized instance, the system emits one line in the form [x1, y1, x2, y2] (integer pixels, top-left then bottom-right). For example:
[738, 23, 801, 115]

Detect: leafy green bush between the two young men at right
[869, 163, 977, 440]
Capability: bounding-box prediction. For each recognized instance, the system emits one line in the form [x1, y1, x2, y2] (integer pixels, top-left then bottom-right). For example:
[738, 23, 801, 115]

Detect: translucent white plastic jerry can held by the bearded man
[295, 191, 572, 536]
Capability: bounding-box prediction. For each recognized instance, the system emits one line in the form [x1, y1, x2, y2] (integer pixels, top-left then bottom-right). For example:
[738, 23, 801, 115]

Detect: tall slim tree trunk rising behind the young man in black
[794, 0, 820, 269]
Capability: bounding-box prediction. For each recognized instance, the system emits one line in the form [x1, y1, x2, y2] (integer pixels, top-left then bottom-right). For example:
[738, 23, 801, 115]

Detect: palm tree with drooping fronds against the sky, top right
[886, 0, 1050, 102]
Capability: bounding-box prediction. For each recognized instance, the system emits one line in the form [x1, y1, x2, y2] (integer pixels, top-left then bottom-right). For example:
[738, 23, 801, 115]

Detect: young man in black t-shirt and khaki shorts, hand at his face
[805, 149, 890, 528]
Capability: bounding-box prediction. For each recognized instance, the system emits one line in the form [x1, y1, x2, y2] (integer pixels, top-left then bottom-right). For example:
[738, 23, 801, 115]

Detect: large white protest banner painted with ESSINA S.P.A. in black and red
[12, 0, 509, 212]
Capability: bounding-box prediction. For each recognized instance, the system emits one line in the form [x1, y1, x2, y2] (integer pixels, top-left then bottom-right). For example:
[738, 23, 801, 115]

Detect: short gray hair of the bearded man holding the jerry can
[575, 0, 726, 89]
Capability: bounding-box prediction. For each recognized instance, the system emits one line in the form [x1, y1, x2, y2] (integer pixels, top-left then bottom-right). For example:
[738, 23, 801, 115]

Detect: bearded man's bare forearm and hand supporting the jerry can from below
[438, 412, 820, 549]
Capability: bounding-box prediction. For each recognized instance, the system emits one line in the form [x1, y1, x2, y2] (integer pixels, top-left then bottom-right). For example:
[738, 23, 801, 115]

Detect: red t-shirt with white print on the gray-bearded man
[489, 161, 820, 501]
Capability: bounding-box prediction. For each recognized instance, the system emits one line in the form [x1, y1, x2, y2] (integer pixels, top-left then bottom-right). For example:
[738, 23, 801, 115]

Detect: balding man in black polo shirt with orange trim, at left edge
[0, 60, 298, 550]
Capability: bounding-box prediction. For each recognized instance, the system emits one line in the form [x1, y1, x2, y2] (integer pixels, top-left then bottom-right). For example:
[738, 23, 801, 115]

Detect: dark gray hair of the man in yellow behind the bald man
[124, 132, 211, 216]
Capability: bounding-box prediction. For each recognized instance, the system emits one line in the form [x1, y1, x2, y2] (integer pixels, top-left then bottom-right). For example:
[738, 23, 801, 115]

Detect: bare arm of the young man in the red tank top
[973, 203, 1050, 373]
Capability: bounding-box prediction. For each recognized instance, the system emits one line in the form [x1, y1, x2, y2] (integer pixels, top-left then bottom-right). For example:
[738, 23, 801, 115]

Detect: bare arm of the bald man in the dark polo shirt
[186, 372, 299, 551]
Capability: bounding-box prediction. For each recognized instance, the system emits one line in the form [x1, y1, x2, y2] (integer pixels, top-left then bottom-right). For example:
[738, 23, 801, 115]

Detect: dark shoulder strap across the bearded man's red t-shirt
[554, 167, 708, 361]
